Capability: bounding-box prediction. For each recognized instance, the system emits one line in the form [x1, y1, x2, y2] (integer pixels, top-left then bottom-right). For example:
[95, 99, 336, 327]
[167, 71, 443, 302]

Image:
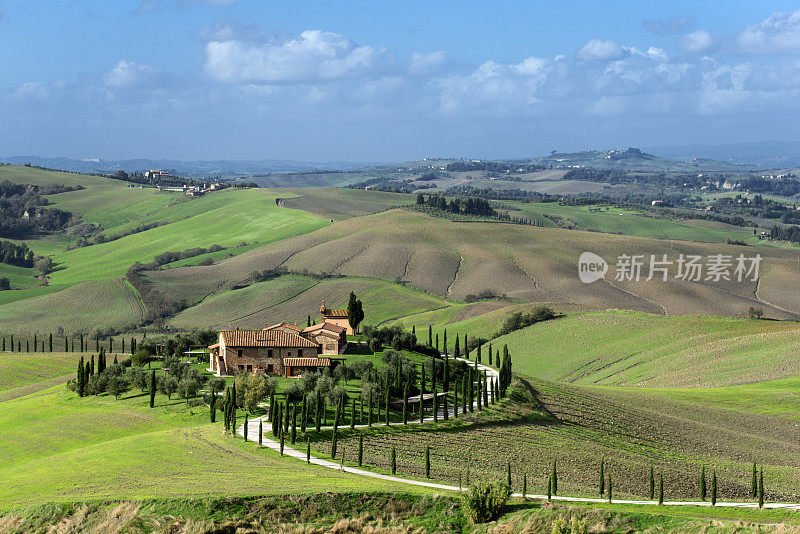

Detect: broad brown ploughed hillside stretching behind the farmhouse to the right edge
[145, 210, 800, 318]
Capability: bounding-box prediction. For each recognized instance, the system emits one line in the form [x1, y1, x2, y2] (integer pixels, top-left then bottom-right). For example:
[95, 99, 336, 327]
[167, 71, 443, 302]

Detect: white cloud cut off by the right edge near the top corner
[736, 9, 800, 55]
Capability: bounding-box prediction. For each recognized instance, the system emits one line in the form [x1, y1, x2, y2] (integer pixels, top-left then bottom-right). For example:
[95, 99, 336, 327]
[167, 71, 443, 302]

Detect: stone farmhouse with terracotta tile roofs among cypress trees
[209, 301, 352, 377]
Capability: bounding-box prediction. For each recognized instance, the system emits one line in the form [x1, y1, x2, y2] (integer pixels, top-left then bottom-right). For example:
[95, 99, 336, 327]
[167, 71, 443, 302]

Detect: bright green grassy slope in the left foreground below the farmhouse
[0, 353, 426, 510]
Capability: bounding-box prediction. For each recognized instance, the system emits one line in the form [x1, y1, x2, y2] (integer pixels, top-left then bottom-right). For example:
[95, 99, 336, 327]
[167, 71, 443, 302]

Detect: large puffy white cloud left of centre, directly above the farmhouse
[205, 30, 391, 84]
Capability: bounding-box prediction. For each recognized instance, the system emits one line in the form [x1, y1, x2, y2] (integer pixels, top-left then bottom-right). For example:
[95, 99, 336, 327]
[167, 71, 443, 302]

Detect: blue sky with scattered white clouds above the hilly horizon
[0, 0, 800, 162]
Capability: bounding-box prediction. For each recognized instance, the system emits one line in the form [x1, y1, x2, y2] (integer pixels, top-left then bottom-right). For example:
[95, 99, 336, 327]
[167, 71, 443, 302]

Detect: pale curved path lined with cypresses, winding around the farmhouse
[236, 358, 800, 510]
